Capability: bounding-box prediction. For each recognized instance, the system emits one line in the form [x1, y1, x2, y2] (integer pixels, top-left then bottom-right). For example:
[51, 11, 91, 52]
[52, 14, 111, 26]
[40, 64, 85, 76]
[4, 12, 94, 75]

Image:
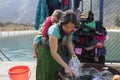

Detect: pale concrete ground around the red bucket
[0, 61, 36, 80]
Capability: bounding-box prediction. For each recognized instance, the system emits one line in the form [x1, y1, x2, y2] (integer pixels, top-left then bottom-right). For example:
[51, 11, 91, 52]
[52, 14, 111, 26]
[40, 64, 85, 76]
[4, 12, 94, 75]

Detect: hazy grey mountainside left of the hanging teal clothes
[0, 0, 38, 23]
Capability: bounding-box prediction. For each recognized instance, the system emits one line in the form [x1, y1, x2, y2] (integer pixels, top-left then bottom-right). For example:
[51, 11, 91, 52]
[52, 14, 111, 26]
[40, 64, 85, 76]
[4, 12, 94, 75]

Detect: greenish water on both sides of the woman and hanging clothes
[0, 30, 120, 62]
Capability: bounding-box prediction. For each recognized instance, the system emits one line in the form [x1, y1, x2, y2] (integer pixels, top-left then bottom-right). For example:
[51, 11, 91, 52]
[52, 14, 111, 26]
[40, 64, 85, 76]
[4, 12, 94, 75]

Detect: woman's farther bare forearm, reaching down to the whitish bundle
[66, 35, 76, 57]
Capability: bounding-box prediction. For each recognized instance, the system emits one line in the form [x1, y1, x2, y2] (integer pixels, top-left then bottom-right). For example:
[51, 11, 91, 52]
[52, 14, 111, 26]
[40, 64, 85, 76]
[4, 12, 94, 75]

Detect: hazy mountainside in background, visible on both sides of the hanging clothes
[0, 0, 120, 26]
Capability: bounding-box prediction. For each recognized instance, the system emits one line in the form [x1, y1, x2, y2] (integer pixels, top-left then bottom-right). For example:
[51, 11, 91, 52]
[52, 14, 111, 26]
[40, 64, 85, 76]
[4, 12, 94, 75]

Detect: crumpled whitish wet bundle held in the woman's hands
[68, 57, 82, 78]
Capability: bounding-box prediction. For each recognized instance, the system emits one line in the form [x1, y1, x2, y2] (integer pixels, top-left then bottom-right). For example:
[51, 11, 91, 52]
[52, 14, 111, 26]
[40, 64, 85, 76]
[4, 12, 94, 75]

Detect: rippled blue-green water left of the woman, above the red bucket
[0, 34, 35, 61]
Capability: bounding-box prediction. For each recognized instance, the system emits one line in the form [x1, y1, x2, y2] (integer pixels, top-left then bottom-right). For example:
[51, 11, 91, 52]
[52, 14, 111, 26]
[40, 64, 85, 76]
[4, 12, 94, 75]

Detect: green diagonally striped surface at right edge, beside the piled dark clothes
[105, 30, 120, 62]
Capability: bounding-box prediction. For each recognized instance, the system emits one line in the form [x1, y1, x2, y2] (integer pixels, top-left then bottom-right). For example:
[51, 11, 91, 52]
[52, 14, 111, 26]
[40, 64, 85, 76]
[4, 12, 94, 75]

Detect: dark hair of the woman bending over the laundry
[60, 10, 77, 25]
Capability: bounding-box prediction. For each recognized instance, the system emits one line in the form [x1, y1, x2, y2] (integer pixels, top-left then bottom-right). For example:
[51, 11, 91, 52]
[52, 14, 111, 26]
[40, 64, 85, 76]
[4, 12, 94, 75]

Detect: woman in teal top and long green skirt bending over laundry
[36, 10, 76, 80]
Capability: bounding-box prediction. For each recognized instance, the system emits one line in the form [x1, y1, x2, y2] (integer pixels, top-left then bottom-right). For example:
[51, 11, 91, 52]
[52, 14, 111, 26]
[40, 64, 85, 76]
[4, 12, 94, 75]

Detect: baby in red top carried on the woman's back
[33, 9, 63, 58]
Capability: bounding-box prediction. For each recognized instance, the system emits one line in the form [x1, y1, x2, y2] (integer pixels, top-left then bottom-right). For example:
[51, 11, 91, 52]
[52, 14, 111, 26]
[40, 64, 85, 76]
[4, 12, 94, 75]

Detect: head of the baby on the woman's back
[51, 9, 63, 23]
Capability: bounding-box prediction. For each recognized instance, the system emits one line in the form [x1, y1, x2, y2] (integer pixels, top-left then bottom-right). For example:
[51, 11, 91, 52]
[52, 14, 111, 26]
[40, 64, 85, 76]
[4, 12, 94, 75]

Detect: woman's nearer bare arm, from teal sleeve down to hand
[49, 35, 73, 76]
